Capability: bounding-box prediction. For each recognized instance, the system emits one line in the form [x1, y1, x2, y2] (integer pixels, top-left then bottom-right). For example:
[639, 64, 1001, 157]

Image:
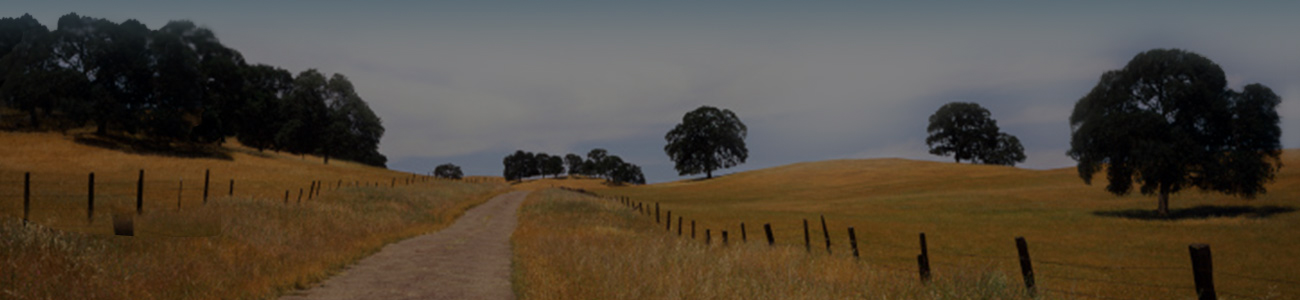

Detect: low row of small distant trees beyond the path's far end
[502, 148, 646, 184]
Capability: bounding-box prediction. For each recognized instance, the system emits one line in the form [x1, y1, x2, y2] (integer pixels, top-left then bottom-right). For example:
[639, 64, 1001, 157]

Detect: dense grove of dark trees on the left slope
[0, 13, 387, 166]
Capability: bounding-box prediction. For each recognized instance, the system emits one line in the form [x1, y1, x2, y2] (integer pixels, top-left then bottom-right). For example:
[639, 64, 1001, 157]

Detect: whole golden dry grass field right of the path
[514, 151, 1300, 299]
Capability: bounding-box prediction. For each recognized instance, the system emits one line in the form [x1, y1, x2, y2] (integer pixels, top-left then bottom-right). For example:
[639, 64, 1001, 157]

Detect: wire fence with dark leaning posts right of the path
[563, 188, 1300, 300]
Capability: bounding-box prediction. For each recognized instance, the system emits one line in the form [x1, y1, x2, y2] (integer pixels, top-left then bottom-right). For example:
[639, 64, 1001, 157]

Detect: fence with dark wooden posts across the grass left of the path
[0, 170, 489, 236]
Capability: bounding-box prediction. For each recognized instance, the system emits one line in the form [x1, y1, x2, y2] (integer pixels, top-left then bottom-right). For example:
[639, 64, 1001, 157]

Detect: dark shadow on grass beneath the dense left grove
[73, 134, 234, 160]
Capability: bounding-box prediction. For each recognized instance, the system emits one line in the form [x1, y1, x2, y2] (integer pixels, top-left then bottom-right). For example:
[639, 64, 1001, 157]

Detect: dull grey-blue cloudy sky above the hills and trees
[10, 0, 1300, 182]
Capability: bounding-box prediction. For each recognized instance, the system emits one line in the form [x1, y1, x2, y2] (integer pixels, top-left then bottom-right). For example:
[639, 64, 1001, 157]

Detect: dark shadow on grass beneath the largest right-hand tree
[1092, 205, 1296, 221]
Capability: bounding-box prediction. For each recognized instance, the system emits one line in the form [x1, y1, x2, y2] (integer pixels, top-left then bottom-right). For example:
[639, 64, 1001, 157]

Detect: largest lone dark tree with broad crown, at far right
[1067, 49, 1282, 217]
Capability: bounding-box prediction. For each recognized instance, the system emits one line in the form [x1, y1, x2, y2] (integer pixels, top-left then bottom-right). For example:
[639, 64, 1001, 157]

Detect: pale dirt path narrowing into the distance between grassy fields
[281, 191, 528, 300]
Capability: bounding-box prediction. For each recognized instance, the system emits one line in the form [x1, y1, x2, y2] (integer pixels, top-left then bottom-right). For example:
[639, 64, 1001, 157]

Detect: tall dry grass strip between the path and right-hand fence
[512, 190, 1024, 299]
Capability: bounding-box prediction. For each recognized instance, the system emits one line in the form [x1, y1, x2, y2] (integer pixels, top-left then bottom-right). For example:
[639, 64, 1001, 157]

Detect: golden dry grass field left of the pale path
[0, 132, 507, 299]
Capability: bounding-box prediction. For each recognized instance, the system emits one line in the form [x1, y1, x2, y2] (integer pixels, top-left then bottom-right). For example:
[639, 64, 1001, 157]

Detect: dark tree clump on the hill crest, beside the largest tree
[926, 103, 1024, 166]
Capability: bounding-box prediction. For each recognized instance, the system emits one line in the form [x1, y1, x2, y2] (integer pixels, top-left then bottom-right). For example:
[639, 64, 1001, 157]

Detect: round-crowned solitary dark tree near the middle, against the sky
[663, 105, 749, 178]
